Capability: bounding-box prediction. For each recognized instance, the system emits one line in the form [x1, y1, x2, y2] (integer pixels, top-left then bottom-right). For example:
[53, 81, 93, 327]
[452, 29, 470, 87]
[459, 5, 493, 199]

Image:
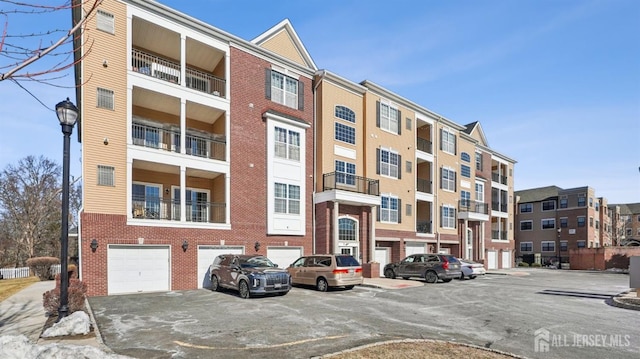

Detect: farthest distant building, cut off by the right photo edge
[608, 203, 640, 246]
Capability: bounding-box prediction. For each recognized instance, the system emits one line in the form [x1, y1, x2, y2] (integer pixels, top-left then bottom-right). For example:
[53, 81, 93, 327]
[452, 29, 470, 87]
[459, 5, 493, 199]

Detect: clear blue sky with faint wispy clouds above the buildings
[0, 0, 640, 203]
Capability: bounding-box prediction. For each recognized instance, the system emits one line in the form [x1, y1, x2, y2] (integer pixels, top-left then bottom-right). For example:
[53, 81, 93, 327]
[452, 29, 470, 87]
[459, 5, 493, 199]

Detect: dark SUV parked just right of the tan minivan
[384, 254, 462, 283]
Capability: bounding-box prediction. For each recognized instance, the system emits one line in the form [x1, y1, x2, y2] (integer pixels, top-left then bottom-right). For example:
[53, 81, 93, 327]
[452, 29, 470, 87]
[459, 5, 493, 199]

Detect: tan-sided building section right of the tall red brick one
[314, 74, 515, 274]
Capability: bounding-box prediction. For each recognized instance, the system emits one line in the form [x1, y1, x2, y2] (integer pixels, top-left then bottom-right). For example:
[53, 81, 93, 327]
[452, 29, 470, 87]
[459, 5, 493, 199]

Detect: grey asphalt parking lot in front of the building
[89, 269, 640, 358]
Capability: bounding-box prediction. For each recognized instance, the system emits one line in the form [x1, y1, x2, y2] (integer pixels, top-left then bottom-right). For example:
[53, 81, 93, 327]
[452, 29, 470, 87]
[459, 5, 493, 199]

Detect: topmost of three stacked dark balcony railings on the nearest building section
[131, 49, 226, 97]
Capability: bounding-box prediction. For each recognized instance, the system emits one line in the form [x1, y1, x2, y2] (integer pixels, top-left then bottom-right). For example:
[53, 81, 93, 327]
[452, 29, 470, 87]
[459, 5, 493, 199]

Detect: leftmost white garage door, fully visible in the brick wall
[107, 245, 171, 294]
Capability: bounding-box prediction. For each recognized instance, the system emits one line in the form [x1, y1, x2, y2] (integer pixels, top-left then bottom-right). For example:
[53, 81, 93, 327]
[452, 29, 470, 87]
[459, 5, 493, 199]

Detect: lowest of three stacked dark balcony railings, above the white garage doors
[132, 196, 226, 223]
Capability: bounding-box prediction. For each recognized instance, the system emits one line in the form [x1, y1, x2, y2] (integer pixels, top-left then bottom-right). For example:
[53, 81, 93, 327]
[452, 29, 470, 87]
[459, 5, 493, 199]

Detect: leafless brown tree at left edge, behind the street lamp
[0, 156, 68, 267]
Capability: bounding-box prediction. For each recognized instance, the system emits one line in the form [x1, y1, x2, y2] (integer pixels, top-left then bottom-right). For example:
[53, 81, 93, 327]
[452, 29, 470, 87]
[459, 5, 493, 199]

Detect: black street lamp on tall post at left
[56, 97, 78, 321]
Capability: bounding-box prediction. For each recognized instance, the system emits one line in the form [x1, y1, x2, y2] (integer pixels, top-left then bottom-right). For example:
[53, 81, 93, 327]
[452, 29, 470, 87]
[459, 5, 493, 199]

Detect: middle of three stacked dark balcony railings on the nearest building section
[132, 123, 227, 161]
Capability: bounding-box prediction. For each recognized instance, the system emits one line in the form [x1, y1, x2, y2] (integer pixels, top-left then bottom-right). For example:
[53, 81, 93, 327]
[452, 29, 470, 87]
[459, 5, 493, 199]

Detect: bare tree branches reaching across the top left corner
[0, 0, 102, 87]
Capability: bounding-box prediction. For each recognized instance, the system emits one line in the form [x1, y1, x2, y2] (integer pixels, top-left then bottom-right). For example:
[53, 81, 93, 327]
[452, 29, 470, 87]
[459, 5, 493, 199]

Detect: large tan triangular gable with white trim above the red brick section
[251, 19, 318, 71]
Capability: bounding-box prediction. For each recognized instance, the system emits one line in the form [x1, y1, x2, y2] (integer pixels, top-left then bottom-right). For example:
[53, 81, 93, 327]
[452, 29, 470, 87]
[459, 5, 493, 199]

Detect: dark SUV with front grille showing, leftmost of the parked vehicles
[209, 254, 291, 298]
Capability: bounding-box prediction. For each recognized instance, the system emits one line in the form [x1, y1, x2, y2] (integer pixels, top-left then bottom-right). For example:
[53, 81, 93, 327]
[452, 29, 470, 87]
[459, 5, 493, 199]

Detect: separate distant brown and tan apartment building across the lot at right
[515, 186, 612, 265]
